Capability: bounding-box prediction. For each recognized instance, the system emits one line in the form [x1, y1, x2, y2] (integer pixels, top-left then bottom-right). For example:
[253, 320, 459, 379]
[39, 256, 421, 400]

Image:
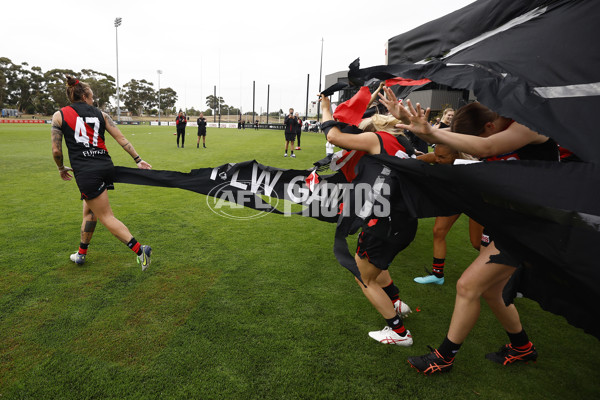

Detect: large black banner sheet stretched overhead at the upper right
[348, 0, 600, 163]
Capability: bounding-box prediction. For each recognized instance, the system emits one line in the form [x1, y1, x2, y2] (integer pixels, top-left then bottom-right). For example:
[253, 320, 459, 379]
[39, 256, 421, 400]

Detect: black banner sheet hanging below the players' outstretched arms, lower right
[375, 155, 600, 338]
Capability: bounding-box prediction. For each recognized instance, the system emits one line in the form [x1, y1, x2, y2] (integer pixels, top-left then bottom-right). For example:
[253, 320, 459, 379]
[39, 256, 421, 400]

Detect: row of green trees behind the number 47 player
[0, 57, 177, 116]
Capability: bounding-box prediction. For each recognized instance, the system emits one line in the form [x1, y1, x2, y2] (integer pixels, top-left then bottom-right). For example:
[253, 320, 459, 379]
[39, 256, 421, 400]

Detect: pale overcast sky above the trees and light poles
[0, 0, 473, 113]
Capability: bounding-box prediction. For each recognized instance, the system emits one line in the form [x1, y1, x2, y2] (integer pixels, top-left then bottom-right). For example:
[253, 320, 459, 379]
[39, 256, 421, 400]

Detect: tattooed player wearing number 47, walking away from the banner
[52, 75, 152, 270]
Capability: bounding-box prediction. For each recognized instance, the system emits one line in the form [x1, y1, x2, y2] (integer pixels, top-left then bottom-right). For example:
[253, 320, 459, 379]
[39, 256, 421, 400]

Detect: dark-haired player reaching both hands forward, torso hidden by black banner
[382, 90, 558, 374]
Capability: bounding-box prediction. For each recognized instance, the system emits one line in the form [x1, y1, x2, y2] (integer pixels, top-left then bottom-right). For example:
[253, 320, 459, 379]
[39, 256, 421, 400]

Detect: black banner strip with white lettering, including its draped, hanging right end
[115, 157, 418, 279]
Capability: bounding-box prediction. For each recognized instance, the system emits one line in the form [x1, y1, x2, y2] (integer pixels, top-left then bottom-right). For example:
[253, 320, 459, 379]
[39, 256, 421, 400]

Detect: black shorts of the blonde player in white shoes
[356, 216, 418, 270]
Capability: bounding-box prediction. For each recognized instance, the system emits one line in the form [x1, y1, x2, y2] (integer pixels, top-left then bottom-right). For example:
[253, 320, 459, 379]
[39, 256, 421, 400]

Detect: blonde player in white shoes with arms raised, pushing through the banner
[321, 96, 417, 346]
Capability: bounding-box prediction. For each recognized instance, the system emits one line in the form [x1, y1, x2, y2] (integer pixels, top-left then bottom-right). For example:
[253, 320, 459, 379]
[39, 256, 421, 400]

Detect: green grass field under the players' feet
[0, 124, 600, 400]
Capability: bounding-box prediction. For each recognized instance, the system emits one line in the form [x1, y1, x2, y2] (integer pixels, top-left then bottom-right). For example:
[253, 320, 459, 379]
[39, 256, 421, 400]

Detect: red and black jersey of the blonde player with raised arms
[340, 131, 414, 182]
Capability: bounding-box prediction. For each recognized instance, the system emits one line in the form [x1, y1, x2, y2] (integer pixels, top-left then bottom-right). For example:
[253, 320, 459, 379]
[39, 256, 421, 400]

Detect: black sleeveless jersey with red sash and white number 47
[60, 102, 113, 174]
